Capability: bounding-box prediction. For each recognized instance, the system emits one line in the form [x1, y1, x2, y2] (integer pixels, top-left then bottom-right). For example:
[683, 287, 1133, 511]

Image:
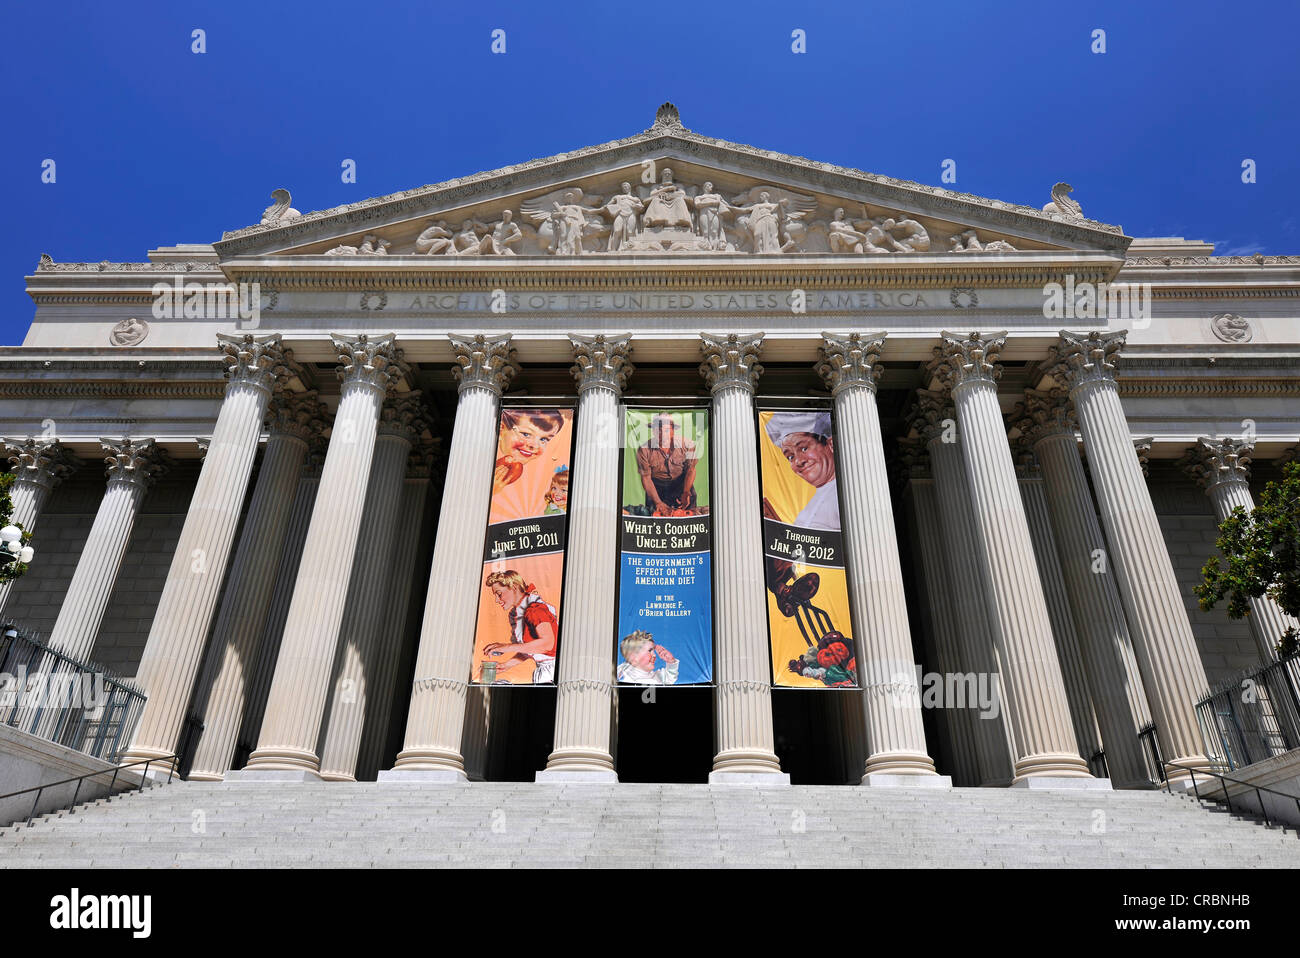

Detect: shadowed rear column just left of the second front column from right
[913, 390, 1014, 786]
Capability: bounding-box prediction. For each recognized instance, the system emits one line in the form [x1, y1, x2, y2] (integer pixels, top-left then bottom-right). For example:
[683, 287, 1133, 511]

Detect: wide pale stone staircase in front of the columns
[0, 783, 1300, 868]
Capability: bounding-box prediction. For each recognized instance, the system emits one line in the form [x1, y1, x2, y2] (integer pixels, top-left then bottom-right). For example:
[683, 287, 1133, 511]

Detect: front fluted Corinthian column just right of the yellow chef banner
[816, 333, 952, 785]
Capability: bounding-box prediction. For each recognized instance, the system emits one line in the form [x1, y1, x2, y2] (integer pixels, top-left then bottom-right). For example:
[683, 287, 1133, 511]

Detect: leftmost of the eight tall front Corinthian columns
[122, 334, 289, 762]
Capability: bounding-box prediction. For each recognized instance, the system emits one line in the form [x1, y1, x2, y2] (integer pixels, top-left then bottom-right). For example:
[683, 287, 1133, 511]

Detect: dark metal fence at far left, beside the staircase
[0, 623, 146, 762]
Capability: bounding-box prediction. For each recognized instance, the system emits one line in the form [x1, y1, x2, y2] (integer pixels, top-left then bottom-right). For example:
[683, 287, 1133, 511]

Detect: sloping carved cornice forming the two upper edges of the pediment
[215, 112, 1130, 259]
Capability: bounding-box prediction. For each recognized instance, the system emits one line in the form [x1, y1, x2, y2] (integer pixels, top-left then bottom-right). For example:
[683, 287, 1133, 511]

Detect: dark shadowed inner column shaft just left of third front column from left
[358, 465, 432, 779]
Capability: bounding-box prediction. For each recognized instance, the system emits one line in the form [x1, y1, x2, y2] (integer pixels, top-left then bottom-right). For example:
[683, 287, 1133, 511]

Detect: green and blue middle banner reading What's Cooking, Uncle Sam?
[615, 407, 714, 685]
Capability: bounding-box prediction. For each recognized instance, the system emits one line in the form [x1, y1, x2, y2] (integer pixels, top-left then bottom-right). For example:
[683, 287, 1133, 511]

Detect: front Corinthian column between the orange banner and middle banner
[537, 333, 633, 781]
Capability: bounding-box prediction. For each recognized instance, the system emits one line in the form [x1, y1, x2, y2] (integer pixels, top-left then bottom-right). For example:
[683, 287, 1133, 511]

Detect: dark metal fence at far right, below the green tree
[1196, 655, 1300, 770]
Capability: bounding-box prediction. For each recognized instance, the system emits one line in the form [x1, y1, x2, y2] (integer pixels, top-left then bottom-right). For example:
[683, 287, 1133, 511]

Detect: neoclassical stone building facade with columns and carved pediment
[0, 104, 1300, 788]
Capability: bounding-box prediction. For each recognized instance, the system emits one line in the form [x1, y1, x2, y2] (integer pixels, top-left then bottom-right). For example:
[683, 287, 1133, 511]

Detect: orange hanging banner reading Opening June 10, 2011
[469, 407, 573, 685]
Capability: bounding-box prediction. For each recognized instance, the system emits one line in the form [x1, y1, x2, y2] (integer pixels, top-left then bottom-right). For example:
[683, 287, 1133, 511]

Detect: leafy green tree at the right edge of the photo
[1196, 461, 1300, 655]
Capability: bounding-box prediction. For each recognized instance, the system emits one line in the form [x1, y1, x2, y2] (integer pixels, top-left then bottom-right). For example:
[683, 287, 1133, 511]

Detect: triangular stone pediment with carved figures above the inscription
[216, 105, 1130, 260]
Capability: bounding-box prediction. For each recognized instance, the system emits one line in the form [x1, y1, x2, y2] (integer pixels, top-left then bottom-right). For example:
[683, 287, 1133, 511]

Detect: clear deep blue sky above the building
[0, 0, 1300, 344]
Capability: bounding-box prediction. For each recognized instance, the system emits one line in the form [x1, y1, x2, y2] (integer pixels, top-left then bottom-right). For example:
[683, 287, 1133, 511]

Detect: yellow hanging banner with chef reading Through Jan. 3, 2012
[758, 408, 858, 689]
